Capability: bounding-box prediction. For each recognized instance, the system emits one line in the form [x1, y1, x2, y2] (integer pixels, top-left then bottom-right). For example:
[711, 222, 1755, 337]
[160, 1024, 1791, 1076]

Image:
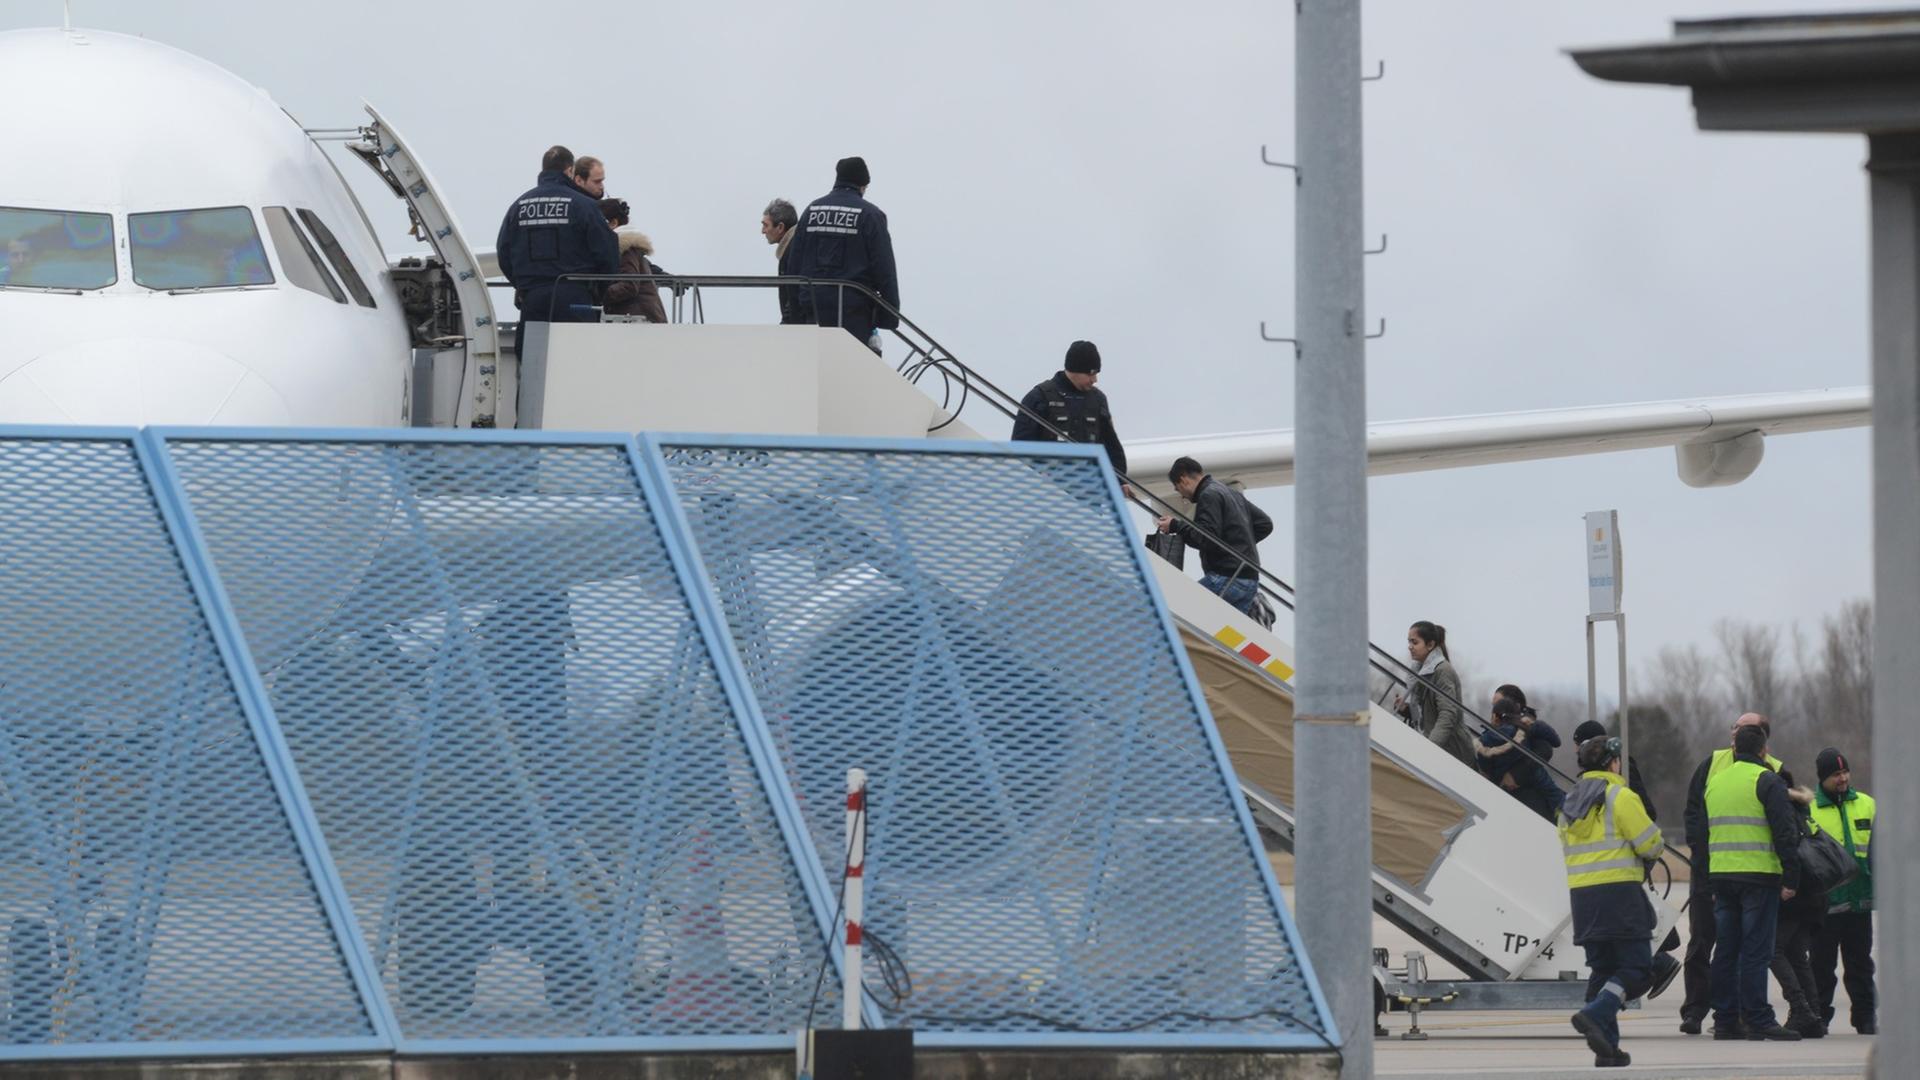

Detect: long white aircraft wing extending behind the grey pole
[1127, 386, 1872, 498]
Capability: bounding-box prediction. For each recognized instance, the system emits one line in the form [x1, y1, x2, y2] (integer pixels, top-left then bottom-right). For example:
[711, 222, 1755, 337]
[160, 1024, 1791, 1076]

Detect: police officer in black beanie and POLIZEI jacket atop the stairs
[781, 158, 900, 352]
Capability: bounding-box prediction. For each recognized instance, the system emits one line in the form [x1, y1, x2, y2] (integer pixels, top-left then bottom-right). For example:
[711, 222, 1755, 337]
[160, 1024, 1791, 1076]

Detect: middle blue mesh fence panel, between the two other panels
[169, 434, 839, 1045]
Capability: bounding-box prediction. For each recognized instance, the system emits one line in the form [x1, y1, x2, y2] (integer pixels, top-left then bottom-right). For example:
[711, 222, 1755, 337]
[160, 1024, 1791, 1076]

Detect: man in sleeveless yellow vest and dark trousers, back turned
[1707, 724, 1801, 1042]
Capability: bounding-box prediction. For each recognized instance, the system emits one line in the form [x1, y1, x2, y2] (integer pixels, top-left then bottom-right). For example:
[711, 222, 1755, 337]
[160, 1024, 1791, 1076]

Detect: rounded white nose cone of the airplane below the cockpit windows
[0, 338, 294, 427]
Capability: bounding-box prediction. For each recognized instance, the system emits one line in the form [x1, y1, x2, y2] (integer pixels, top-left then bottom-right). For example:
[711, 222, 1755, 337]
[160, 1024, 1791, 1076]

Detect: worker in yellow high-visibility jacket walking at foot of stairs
[1557, 738, 1661, 1068]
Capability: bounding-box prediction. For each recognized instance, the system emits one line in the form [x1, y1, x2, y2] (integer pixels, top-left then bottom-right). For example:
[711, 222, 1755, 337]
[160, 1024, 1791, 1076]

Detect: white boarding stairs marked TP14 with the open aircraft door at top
[345, 110, 1678, 1034]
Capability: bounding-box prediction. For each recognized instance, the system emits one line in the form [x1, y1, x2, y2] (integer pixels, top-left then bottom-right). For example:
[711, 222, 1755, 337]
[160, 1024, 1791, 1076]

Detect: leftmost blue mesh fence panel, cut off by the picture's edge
[0, 436, 378, 1057]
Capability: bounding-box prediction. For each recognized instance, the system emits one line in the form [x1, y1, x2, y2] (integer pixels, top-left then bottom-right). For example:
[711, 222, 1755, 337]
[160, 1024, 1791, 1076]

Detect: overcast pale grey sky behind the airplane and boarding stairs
[0, 0, 1870, 703]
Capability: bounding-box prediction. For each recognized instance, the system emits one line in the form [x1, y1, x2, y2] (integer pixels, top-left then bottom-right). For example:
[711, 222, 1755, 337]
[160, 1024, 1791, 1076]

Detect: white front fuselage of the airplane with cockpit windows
[0, 31, 409, 427]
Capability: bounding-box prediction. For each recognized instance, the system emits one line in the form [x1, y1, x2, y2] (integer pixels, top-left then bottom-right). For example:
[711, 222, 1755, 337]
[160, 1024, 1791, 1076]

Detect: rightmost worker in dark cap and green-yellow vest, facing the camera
[1812, 746, 1880, 1036]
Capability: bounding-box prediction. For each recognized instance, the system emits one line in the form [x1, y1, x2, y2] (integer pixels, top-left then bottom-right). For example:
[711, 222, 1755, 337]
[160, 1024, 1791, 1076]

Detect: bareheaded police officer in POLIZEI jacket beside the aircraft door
[495, 146, 620, 356]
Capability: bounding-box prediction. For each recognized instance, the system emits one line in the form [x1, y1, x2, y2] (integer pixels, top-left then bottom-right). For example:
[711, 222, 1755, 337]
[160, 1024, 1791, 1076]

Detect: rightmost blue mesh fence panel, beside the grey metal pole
[662, 440, 1321, 1045]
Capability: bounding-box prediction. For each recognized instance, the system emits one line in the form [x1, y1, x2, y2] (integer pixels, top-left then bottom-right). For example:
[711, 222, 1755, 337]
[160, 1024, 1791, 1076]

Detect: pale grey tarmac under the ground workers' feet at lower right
[1336, 882, 1874, 1080]
